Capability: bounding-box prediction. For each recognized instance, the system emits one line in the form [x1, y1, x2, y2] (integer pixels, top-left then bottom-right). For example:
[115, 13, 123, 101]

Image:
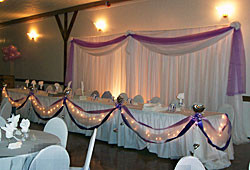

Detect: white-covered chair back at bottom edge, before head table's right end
[174, 156, 205, 170]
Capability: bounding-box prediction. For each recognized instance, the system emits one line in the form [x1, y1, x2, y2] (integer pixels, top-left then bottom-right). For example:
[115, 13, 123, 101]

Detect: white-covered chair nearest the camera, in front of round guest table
[29, 145, 70, 170]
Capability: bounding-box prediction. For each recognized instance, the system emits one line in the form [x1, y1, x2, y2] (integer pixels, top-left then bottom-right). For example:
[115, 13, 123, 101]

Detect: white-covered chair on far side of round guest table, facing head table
[43, 117, 68, 148]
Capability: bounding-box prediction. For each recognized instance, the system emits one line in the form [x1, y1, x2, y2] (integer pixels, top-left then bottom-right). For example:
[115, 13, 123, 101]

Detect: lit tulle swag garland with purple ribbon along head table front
[2, 88, 231, 151]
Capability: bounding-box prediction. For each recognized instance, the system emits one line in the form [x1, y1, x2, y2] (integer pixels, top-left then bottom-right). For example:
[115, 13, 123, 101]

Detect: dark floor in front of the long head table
[31, 123, 250, 170]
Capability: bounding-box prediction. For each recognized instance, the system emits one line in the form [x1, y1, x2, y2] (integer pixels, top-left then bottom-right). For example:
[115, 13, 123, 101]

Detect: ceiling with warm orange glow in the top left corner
[0, 0, 102, 23]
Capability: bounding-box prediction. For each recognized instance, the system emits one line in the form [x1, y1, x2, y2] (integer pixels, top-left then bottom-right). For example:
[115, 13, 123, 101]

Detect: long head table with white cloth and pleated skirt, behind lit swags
[2, 89, 234, 169]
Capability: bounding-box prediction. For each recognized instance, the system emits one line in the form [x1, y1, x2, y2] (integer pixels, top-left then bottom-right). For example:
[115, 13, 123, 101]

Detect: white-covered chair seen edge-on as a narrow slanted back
[70, 128, 97, 170]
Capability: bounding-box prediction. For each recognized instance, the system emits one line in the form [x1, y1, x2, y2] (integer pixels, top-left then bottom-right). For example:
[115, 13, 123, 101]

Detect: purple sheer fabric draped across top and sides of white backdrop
[65, 26, 246, 96]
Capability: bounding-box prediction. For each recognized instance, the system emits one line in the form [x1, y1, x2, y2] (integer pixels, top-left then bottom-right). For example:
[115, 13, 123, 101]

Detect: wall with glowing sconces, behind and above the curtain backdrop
[0, 0, 250, 95]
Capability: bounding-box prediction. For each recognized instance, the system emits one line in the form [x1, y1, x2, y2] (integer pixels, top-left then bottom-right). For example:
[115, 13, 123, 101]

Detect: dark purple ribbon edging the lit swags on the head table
[2, 90, 231, 151]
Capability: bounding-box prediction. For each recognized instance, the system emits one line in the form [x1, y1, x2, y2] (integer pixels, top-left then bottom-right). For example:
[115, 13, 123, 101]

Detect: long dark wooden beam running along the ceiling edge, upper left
[0, 0, 133, 28]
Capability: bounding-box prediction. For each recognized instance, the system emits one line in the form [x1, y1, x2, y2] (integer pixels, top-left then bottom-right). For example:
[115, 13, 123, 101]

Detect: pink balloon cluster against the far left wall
[2, 45, 21, 61]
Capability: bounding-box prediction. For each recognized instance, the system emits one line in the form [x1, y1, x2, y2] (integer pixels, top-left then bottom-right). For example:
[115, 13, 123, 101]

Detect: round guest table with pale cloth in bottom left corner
[0, 130, 60, 170]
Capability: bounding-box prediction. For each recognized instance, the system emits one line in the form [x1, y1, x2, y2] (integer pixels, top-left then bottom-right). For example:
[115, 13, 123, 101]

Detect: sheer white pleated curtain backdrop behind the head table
[73, 26, 247, 143]
